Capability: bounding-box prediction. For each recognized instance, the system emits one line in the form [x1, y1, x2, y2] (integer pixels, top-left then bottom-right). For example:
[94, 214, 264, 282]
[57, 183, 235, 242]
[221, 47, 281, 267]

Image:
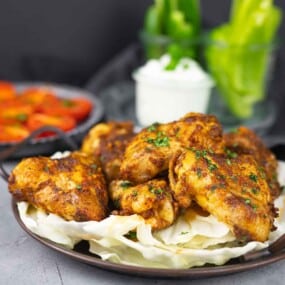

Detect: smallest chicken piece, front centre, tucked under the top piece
[109, 179, 178, 230]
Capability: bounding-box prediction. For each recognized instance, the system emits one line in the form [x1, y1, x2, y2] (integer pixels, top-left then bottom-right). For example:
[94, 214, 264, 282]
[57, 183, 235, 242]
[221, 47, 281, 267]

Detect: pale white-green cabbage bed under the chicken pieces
[18, 162, 285, 269]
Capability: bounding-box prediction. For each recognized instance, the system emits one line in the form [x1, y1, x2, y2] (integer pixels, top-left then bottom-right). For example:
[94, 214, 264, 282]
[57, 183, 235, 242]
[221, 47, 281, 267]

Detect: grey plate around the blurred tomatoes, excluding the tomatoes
[0, 82, 104, 158]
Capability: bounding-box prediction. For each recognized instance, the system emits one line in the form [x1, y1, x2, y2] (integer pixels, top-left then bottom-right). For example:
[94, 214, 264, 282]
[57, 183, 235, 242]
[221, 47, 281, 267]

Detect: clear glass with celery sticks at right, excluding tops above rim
[204, 35, 279, 132]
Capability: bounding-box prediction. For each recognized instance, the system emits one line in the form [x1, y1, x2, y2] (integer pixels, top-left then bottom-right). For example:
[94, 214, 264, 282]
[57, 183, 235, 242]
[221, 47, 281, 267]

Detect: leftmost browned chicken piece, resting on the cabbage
[9, 152, 108, 221]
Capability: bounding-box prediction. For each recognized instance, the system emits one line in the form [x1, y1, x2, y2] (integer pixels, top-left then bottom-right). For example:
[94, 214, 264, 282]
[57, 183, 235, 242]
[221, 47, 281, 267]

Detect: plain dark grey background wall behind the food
[0, 0, 285, 134]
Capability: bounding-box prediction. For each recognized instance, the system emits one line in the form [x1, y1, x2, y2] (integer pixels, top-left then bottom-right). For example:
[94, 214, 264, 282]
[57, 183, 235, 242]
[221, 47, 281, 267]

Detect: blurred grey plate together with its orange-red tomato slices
[0, 81, 103, 156]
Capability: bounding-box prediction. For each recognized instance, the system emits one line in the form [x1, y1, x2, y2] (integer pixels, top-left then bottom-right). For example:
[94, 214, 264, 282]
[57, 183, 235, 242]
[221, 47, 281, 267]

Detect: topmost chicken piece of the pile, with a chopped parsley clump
[120, 113, 223, 183]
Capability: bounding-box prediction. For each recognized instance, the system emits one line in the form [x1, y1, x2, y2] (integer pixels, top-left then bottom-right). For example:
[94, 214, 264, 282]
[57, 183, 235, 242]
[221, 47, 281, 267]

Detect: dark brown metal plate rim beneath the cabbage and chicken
[12, 200, 285, 279]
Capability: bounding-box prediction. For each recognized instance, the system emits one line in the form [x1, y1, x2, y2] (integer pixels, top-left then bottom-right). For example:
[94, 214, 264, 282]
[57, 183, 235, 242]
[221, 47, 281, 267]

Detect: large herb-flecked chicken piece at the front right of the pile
[170, 149, 275, 242]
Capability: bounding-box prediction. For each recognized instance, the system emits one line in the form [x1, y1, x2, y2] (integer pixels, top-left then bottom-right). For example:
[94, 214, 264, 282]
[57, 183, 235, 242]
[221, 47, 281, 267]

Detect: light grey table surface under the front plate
[0, 162, 285, 285]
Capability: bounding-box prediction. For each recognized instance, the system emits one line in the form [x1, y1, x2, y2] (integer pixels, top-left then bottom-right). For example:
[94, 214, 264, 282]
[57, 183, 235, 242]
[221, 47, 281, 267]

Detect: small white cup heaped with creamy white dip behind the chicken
[133, 55, 214, 126]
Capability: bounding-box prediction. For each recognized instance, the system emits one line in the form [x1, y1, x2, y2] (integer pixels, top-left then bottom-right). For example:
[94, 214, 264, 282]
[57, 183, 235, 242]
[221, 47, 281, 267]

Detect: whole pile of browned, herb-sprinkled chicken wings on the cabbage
[9, 113, 281, 241]
